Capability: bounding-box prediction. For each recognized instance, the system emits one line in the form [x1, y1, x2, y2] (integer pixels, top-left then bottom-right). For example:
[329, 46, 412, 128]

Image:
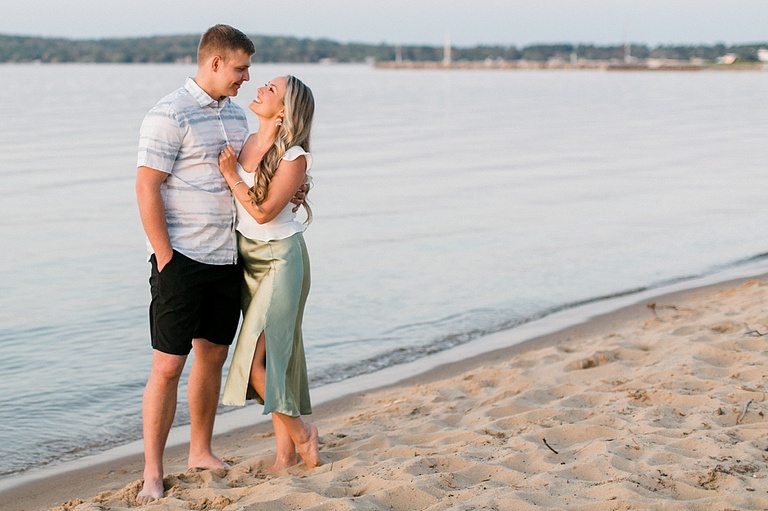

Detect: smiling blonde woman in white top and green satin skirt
[219, 76, 320, 472]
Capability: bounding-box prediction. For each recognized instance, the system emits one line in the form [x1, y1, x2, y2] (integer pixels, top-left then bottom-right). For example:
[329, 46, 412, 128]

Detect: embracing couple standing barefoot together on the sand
[136, 25, 320, 505]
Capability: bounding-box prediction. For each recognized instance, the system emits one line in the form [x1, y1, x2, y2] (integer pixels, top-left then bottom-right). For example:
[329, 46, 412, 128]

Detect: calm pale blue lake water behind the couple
[0, 65, 768, 475]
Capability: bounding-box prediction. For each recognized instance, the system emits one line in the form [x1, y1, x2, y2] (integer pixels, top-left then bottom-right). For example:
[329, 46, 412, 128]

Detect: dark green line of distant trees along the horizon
[0, 35, 768, 63]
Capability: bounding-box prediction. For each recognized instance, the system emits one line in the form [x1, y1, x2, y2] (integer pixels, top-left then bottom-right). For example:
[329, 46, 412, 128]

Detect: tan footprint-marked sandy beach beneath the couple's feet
[0, 277, 768, 511]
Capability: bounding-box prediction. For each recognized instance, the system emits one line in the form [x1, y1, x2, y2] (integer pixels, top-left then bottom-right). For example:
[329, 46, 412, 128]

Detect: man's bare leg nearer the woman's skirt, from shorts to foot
[187, 339, 229, 469]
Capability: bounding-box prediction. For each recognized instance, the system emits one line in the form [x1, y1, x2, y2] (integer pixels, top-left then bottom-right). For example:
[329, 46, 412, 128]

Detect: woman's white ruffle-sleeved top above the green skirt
[235, 146, 312, 241]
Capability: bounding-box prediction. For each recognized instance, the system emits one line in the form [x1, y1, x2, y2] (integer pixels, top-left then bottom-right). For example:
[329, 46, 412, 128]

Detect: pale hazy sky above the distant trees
[0, 0, 768, 47]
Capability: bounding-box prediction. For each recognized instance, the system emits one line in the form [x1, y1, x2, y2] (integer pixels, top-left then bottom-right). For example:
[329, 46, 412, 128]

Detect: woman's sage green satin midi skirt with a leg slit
[222, 233, 312, 417]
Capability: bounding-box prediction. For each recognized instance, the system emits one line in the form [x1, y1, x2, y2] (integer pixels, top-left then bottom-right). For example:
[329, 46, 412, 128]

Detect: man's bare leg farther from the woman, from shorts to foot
[136, 350, 187, 505]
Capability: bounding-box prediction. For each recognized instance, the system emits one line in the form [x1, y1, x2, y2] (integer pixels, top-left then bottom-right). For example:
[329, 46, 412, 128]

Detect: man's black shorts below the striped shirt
[149, 250, 238, 355]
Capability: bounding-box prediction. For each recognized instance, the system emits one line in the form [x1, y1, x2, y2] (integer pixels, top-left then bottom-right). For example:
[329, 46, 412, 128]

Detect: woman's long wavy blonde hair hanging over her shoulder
[249, 75, 315, 225]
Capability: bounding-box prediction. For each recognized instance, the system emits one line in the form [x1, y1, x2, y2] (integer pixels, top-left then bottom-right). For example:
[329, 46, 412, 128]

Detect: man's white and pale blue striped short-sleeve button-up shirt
[138, 78, 248, 265]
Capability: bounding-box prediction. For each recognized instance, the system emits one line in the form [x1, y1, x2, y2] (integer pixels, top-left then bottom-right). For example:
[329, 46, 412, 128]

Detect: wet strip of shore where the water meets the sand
[0, 264, 768, 511]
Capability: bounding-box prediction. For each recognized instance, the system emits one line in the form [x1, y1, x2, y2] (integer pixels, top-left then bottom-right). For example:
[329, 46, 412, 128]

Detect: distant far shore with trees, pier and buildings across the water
[0, 35, 768, 70]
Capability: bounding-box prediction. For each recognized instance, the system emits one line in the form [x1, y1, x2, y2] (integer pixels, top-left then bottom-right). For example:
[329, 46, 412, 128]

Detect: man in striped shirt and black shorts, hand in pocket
[136, 25, 255, 505]
